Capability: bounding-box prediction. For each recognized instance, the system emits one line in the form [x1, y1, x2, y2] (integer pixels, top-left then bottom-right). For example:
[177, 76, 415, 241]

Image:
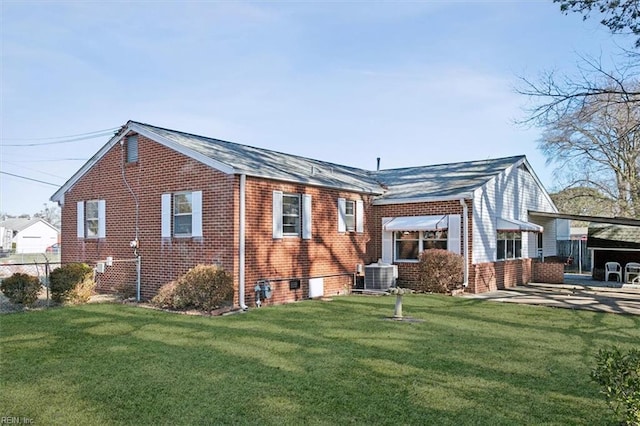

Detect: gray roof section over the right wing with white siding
[374, 155, 525, 201]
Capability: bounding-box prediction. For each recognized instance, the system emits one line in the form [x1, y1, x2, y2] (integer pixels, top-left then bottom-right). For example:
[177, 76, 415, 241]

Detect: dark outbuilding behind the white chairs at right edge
[587, 224, 640, 280]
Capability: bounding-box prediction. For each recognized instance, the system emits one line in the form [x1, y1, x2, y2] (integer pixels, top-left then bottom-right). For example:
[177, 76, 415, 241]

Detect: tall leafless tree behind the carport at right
[535, 80, 640, 217]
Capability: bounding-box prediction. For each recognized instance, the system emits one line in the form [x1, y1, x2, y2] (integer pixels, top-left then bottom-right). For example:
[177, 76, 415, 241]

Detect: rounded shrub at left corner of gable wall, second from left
[49, 263, 96, 304]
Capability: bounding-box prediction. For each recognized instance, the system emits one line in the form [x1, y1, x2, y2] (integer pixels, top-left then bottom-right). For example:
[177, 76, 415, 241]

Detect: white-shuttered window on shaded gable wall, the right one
[161, 191, 202, 238]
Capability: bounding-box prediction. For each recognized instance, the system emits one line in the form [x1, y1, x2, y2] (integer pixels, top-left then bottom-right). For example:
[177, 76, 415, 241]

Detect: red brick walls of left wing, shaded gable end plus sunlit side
[62, 136, 371, 306]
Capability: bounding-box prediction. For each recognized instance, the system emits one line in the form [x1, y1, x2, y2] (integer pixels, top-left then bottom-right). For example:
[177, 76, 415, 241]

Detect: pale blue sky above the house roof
[0, 0, 633, 214]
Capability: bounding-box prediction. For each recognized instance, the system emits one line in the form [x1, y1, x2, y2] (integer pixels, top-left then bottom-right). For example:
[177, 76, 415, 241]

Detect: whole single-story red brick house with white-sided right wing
[51, 121, 557, 307]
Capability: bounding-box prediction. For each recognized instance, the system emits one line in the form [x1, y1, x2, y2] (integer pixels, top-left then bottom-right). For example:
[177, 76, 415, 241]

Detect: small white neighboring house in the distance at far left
[0, 218, 60, 253]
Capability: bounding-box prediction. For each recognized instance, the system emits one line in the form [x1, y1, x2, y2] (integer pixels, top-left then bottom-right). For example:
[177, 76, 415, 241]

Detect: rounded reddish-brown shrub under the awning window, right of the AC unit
[418, 249, 464, 293]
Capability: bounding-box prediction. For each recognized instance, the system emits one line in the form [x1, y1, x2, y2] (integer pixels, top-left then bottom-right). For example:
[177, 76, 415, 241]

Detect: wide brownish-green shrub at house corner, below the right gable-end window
[151, 265, 233, 312]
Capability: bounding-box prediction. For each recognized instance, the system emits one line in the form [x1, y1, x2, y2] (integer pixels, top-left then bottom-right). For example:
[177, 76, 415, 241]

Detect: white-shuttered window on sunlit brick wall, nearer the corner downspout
[273, 191, 311, 239]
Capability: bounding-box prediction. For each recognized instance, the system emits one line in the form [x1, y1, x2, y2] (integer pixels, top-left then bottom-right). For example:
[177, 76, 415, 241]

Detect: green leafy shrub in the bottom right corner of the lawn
[591, 346, 640, 425]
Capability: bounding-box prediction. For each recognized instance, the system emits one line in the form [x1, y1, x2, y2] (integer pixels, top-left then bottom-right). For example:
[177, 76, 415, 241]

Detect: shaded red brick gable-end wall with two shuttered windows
[61, 136, 237, 298]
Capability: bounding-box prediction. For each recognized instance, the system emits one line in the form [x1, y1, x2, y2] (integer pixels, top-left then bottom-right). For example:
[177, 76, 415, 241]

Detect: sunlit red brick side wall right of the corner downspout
[240, 177, 371, 305]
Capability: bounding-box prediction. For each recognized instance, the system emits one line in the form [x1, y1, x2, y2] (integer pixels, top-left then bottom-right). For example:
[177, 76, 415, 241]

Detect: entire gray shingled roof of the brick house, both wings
[51, 121, 526, 203]
